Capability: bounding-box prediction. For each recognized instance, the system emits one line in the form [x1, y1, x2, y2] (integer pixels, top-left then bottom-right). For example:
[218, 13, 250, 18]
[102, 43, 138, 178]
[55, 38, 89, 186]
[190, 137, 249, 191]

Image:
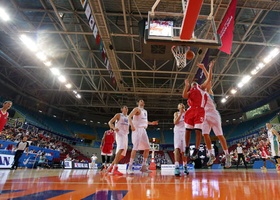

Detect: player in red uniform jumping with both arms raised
[182, 65, 210, 160]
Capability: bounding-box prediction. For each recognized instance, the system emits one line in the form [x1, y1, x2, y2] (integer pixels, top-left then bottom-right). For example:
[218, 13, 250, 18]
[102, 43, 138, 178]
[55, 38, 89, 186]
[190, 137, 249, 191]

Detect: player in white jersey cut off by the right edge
[266, 123, 280, 171]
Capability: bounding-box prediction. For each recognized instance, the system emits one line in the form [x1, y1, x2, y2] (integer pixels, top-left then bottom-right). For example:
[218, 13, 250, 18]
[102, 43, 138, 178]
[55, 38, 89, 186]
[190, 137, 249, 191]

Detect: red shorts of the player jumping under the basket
[184, 107, 205, 129]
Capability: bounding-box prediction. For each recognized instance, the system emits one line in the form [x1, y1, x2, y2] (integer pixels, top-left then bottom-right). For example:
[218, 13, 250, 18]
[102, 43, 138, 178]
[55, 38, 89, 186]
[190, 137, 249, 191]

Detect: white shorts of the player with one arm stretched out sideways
[131, 127, 150, 151]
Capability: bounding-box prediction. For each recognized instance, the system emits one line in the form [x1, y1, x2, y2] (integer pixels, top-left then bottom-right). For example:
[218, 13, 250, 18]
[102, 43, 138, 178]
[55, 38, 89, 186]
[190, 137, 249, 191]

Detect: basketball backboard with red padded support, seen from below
[144, 0, 221, 49]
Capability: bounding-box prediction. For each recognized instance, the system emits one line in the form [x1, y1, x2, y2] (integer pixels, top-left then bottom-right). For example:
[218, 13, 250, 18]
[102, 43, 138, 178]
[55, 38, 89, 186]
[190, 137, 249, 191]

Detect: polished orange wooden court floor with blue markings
[0, 169, 280, 200]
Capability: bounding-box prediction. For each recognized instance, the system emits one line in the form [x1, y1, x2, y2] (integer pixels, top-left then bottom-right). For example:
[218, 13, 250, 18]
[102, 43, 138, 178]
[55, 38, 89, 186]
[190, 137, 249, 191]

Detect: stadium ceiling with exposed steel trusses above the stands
[0, 0, 280, 126]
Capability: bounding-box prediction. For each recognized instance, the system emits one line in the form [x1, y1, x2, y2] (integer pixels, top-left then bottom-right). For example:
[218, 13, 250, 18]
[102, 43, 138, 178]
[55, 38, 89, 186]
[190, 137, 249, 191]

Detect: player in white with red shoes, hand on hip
[107, 106, 129, 175]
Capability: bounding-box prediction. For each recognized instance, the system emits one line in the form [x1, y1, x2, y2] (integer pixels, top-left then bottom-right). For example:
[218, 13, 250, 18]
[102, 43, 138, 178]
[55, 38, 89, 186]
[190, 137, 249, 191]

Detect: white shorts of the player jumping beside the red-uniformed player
[202, 110, 223, 136]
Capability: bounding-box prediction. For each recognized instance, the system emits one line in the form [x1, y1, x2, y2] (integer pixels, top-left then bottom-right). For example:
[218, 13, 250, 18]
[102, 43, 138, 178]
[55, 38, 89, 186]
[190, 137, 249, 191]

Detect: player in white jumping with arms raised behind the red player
[198, 61, 231, 168]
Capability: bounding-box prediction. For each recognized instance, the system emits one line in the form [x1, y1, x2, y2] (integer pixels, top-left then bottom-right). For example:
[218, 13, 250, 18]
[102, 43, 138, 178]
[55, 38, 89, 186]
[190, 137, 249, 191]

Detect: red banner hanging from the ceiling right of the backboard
[218, 0, 237, 54]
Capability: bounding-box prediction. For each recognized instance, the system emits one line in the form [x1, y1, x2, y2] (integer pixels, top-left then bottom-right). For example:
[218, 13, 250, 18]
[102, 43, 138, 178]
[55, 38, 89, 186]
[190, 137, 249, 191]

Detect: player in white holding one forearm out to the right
[127, 99, 158, 174]
